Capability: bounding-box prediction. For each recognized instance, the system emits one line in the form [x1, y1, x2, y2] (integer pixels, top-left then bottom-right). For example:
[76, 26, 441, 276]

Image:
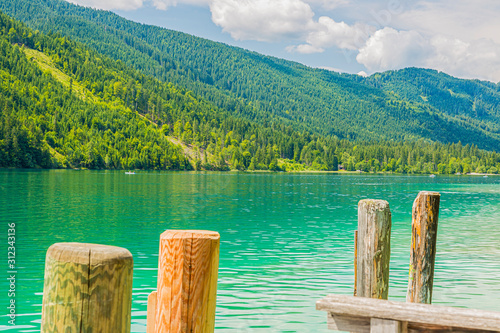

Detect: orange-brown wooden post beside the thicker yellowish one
[154, 230, 220, 333]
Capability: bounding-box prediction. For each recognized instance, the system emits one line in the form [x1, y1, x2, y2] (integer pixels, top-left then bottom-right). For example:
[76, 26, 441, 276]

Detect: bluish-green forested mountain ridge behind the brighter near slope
[0, 0, 500, 150]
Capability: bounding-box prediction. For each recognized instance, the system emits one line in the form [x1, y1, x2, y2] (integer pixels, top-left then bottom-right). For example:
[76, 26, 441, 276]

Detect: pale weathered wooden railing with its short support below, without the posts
[316, 295, 500, 333]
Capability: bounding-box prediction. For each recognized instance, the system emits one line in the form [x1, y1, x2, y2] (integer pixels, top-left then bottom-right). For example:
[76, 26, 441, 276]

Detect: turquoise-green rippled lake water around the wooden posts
[0, 170, 500, 332]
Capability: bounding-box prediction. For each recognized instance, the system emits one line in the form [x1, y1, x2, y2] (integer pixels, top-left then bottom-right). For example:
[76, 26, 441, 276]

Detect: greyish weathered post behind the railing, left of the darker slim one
[356, 200, 391, 299]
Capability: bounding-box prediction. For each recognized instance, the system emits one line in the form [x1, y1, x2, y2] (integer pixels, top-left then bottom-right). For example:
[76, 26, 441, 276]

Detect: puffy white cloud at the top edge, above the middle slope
[210, 0, 314, 41]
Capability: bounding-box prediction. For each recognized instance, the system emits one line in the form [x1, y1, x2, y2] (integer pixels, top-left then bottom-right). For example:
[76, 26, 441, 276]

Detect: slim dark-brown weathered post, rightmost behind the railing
[406, 192, 441, 304]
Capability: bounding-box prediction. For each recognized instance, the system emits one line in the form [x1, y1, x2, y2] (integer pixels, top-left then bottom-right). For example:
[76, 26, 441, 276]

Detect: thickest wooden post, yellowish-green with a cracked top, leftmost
[41, 243, 133, 333]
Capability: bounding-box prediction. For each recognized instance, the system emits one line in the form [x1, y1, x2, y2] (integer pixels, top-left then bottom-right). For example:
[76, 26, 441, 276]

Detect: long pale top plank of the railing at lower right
[316, 295, 500, 331]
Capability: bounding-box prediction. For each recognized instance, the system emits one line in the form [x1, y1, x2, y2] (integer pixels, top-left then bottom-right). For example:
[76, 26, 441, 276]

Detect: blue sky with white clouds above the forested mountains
[65, 0, 500, 82]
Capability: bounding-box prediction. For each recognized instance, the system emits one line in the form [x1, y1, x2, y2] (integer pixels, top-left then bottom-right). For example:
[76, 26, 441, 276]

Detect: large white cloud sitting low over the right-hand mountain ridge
[356, 28, 500, 82]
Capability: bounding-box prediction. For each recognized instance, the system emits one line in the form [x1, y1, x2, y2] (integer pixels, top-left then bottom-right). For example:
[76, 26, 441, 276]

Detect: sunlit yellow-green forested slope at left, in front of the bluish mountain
[0, 13, 324, 170]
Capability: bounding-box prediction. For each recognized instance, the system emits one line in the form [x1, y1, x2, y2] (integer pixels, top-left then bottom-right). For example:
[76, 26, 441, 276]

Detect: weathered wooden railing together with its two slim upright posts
[316, 192, 500, 333]
